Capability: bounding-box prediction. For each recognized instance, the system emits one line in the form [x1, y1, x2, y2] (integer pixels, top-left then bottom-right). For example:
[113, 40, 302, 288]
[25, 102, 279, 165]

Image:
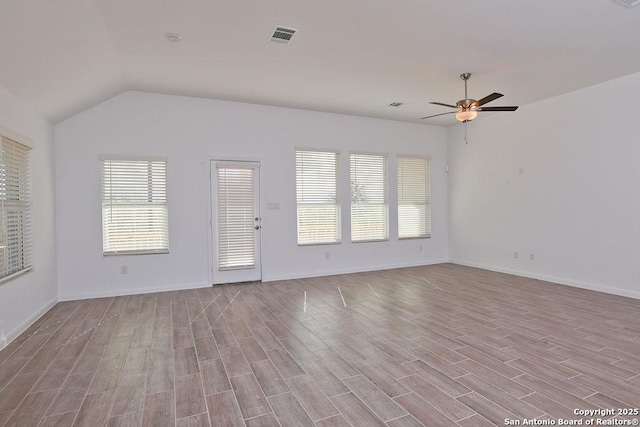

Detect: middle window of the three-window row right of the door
[350, 153, 389, 242]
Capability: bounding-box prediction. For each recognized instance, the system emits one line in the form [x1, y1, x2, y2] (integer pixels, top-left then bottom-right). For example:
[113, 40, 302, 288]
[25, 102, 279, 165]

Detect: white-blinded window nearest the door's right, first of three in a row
[296, 150, 341, 245]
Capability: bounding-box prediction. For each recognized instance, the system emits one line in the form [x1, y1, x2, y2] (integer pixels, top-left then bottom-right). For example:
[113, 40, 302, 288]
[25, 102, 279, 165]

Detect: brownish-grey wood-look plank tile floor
[0, 264, 640, 427]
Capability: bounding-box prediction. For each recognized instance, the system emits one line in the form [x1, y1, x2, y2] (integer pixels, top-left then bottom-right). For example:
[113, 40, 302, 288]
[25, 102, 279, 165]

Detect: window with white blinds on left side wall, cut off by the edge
[0, 137, 32, 279]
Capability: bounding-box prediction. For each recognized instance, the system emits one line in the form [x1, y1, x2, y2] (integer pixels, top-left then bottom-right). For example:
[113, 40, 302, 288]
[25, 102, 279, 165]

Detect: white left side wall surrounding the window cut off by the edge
[0, 87, 57, 349]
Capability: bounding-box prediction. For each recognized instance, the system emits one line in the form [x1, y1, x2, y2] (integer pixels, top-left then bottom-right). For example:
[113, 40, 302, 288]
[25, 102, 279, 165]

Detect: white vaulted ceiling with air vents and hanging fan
[0, 0, 640, 126]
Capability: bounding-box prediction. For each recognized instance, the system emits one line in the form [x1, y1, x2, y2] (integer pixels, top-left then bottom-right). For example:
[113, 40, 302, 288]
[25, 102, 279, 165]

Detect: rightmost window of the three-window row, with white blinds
[398, 156, 431, 239]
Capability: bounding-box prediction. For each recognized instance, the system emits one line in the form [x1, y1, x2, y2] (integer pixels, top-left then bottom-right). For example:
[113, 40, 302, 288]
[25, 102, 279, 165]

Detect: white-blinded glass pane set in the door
[217, 164, 254, 270]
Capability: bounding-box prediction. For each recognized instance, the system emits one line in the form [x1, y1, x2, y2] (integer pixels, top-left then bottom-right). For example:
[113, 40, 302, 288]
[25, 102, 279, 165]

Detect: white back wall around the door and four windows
[55, 92, 448, 299]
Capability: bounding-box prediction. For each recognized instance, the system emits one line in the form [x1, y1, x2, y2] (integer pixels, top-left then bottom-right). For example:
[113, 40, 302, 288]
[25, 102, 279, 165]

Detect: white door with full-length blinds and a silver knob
[211, 161, 262, 284]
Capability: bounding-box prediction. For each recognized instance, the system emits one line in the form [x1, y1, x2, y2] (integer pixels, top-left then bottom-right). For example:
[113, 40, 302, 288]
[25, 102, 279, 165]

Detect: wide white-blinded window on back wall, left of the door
[101, 158, 169, 255]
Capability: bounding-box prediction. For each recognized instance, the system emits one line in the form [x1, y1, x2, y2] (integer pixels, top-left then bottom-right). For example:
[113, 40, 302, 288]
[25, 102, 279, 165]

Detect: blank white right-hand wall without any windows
[448, 74, 640, 298]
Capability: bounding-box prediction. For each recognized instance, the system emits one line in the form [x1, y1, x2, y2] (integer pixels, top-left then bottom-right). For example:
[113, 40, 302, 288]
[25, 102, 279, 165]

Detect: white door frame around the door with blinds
[208, 156, 263, 286]
